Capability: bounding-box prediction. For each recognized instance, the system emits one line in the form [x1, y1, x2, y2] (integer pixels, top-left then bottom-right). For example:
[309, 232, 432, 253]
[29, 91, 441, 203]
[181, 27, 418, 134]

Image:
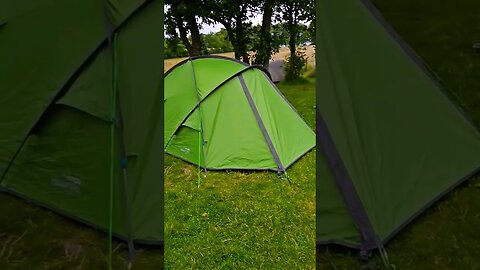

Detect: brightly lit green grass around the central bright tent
[165, 79, 315, 269]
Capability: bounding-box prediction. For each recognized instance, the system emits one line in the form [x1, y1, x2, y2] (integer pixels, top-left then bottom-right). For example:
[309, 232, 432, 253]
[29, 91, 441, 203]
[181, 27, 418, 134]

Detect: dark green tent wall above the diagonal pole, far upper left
[0, 0, 104, 181]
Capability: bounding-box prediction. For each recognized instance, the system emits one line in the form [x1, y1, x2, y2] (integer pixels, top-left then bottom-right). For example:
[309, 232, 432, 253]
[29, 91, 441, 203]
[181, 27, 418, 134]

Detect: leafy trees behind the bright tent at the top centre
[164, 0, 315, 79]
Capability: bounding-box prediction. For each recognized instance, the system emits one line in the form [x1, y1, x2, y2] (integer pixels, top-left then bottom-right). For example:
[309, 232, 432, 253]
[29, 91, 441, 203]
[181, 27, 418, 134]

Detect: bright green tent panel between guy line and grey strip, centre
[195, 75, 277, 170]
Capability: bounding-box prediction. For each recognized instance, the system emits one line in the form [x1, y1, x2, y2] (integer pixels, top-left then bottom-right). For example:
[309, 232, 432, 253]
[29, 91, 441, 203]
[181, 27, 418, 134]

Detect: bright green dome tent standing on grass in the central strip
[164, 56, 315, 173]
